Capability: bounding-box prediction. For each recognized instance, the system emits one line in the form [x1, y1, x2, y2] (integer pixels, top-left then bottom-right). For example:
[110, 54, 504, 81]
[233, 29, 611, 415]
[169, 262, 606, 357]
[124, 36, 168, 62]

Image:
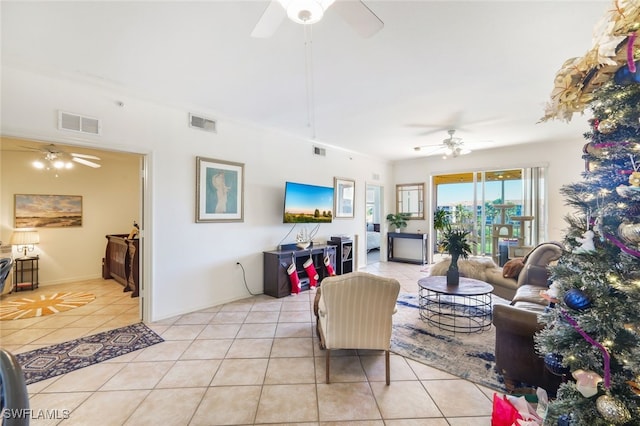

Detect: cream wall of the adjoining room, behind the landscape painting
[0, 138, 140, 286]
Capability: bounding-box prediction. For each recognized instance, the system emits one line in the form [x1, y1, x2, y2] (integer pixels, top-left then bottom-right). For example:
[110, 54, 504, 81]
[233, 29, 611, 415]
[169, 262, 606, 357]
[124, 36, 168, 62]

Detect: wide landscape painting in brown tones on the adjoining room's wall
[14, 194, 82, 228]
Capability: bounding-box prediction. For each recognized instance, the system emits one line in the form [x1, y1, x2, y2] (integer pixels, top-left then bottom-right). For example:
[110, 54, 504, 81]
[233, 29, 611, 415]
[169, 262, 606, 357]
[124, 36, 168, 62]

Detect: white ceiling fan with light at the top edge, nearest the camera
[251, 0, 384, 38]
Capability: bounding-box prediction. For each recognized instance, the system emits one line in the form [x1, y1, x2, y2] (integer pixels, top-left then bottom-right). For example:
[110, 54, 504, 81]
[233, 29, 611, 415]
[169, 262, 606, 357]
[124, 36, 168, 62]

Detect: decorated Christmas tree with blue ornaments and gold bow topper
[536, 1, 640, 426]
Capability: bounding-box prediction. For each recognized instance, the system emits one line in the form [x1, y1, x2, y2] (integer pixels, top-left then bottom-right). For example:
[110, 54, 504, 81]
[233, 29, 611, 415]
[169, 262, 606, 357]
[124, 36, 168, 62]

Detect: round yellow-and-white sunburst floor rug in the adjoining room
[0, 291, 96, 320]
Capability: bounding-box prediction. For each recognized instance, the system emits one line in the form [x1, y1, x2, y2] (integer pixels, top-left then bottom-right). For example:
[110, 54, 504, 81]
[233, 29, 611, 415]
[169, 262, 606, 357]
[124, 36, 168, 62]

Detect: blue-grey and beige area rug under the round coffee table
[391, 293, 508, 392]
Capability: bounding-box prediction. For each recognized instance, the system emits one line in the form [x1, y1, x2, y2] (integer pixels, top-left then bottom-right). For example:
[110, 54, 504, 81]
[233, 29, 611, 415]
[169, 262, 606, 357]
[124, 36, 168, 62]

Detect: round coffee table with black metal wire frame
[418, 275, 493, 333]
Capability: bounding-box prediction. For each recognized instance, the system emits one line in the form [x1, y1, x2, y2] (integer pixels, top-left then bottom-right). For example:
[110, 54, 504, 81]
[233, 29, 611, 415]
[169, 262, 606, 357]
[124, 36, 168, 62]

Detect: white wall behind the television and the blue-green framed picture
[0, 66, 392, 320]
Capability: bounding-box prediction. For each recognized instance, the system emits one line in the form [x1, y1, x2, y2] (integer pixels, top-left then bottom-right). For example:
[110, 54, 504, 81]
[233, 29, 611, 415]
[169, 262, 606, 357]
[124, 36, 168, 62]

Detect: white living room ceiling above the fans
[0, 0, 611, 160]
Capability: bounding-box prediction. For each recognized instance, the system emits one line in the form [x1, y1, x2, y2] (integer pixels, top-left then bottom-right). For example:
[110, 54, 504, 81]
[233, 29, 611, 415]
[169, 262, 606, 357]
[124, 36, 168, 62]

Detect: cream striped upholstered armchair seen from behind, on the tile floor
[318, 272, 400, 385]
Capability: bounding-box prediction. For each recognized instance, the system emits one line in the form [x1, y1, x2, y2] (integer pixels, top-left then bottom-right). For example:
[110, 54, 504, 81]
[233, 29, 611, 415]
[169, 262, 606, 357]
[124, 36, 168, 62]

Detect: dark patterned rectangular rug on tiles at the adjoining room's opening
[16, 323, 164, 384]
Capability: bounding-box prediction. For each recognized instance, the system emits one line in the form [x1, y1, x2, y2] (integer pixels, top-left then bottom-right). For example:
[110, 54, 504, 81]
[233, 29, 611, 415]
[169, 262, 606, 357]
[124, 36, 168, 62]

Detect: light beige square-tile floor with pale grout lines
[0, 262, 493, 426]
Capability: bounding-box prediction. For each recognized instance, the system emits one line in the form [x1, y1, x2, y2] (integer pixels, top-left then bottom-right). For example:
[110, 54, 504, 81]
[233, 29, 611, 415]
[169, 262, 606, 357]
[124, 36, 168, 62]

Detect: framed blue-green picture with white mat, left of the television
[196, 157, 244, 222]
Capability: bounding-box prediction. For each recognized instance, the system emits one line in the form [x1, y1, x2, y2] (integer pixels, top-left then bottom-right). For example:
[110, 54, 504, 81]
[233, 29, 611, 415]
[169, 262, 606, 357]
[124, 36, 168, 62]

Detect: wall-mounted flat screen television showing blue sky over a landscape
[283, 182, 333, 223]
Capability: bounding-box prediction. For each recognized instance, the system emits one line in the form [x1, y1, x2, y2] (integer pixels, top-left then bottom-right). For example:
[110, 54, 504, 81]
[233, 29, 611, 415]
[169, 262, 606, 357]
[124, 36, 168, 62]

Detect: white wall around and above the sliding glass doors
[393, 138, 588, 246]
